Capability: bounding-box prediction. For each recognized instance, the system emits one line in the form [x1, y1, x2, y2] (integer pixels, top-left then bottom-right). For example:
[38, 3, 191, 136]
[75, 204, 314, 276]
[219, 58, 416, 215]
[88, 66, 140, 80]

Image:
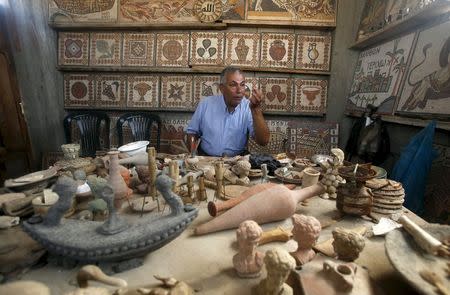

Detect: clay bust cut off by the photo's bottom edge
[256, 248, 295, 295]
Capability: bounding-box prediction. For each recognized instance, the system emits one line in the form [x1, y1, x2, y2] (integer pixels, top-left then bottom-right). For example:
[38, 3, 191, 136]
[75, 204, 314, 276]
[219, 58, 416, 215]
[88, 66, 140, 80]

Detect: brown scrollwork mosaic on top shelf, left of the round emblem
[119, 0, 198, 23]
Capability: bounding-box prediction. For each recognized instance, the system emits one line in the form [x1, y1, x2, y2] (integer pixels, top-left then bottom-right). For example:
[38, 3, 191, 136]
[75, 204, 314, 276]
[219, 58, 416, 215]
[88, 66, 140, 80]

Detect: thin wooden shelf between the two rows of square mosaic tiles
[56, 66, 330, 76]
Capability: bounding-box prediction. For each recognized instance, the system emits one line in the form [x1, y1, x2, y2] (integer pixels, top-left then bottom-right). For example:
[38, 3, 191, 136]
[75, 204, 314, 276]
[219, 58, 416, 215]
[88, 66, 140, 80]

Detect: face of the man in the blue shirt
[220, 72, 245, 108]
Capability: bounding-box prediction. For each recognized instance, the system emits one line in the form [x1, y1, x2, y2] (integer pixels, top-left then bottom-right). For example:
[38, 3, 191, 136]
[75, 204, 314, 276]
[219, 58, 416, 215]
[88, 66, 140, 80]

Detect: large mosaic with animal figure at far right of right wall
[396, 20, 450, 118]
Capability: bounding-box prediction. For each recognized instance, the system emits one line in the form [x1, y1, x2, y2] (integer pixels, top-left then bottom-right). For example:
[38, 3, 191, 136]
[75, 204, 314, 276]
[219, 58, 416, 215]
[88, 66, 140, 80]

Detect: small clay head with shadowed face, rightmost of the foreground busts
[332, 227, 365, 262]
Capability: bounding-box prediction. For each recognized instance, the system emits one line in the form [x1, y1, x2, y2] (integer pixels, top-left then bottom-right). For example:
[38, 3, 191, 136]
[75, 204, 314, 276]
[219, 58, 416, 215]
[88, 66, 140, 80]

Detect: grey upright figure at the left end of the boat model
[44, 176, 78, 226]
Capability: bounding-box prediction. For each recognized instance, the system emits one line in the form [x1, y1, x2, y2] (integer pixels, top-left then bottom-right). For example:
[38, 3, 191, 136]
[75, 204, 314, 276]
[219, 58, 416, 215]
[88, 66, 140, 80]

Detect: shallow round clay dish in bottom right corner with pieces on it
[385, 224, 450, 295]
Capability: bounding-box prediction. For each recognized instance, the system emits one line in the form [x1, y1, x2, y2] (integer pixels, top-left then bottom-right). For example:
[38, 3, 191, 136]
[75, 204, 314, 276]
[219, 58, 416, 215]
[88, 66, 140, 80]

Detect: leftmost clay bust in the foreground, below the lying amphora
[233, 220, 264, 278]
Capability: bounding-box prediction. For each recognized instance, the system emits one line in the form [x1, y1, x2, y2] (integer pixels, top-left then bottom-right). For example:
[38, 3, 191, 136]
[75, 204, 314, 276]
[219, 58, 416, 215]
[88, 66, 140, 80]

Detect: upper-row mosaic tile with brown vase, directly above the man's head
[225, 33, 260, 67]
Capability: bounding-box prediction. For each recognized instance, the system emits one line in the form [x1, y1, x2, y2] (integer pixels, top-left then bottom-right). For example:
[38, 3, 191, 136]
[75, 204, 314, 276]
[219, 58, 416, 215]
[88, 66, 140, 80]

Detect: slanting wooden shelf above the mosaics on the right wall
[350, 0, 450, 49]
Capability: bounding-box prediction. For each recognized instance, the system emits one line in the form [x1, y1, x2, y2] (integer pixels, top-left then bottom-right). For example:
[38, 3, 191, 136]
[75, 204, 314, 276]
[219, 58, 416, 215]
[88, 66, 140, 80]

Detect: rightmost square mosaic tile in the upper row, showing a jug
[295, 33, 331, 71]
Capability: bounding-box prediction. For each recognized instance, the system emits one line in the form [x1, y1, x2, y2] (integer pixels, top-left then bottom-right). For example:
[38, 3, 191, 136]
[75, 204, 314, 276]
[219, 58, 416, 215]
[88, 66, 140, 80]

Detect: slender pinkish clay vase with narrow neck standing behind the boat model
[108, 151, 129, 209]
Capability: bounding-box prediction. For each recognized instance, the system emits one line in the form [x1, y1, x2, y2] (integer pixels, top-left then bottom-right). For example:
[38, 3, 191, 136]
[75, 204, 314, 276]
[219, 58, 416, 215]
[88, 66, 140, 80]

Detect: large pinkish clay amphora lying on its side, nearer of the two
[195, 184, 324, 235]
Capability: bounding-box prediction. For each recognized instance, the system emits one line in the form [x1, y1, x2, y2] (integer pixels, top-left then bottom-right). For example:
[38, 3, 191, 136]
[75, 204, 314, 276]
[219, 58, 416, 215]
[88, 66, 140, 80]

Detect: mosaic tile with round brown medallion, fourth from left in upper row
[156, 33, 189, 67]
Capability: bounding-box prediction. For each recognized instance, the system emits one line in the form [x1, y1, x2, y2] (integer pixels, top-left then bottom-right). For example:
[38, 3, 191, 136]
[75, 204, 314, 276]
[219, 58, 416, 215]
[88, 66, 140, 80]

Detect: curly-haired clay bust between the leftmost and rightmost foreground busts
[291, 214, 322, 265]
